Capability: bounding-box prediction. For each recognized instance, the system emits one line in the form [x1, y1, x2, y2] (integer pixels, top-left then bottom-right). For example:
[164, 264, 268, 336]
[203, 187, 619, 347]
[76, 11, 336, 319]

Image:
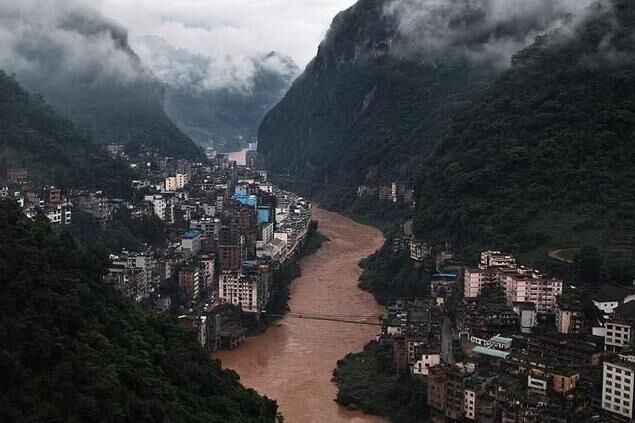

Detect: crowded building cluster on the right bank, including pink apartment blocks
[377, 238, 635, 423]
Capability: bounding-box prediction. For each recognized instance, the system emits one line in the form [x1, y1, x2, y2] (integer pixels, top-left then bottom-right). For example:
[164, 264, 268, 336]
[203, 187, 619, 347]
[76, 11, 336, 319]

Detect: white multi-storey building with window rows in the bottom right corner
[602, 356, 635, 419]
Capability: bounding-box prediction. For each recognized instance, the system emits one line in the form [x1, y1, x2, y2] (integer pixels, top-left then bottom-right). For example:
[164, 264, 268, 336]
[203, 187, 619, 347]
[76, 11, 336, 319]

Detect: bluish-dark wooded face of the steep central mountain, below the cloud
[259, 0, 495, 210]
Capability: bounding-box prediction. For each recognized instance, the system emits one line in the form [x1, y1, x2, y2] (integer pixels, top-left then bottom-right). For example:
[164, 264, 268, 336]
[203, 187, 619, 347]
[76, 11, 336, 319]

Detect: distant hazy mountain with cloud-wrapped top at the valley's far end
[137, 36, 299, 151]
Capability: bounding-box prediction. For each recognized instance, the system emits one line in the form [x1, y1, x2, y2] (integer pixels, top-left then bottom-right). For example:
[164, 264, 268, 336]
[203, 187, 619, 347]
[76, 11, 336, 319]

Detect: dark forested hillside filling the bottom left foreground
[0, 200, 276, 423]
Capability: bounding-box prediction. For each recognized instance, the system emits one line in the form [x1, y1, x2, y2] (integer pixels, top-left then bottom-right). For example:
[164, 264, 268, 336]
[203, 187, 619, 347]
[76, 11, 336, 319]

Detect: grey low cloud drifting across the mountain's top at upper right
[385, 0, 594, 67]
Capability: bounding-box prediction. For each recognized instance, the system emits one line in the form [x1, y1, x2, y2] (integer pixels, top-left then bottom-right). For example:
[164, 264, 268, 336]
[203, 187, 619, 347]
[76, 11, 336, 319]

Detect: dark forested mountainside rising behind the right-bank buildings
[415, 0, 635, 274]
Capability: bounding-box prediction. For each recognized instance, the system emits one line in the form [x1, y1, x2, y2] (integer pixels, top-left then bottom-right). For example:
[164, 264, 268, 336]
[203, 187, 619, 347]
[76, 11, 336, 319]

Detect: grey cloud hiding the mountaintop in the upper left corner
[0, 0, 147, 85]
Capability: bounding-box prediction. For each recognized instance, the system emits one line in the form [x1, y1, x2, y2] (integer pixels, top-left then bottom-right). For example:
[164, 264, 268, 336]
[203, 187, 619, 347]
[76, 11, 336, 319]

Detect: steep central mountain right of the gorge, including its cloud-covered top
[259, 0, 588, 206]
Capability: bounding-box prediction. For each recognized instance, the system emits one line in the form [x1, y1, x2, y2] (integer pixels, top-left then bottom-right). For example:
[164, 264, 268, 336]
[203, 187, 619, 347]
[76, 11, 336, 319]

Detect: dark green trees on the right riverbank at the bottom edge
[333, 342, 428, 423]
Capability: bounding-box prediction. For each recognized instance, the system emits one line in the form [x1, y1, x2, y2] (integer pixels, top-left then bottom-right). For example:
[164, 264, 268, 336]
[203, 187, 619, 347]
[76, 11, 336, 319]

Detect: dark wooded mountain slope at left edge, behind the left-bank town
[0, 71, 131, 195]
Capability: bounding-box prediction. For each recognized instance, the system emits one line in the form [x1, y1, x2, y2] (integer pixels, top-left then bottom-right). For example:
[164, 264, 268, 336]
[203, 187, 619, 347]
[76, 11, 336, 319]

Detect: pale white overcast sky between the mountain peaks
[101, 0, 355, 68]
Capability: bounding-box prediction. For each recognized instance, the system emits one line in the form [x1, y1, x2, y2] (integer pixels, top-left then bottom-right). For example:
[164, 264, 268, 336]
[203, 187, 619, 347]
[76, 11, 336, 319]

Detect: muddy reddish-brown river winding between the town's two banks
[216, 208, 384, 423]
